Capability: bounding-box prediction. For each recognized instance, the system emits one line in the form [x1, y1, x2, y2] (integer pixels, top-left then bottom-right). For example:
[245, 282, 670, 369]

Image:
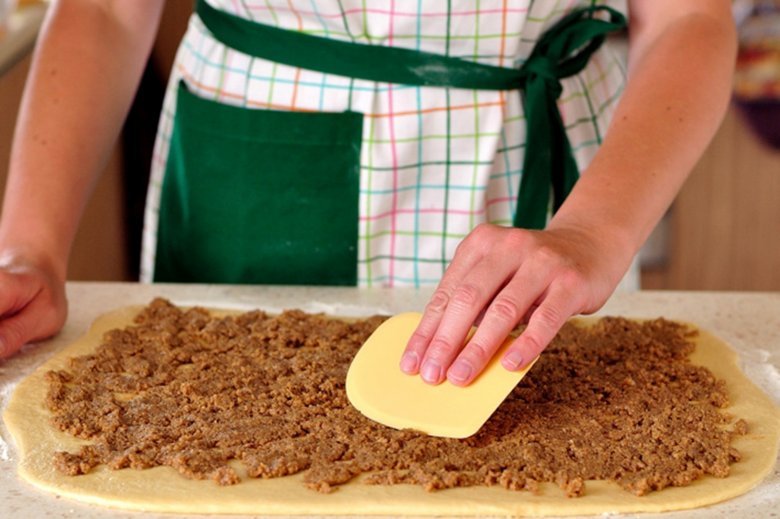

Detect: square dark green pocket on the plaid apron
[154, 82, 363, 285]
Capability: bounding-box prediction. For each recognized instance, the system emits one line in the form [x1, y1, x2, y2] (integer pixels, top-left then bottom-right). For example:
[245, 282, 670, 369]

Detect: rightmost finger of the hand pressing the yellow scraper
[501, 284, 579, 371]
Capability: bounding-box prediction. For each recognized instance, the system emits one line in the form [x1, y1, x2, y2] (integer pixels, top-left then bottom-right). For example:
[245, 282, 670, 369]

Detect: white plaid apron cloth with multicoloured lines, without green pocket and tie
[141, 0, 626, 286]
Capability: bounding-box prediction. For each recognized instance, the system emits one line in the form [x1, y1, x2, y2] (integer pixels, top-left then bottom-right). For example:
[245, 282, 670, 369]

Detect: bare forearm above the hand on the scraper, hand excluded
[550, 2, 736, 255]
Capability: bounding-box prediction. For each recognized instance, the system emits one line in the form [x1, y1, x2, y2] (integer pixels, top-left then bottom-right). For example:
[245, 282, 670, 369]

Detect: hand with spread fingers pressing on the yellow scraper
[401, 224, 633, 386]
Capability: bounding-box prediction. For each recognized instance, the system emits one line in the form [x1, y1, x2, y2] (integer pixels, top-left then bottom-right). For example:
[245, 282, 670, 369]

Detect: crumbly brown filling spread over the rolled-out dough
[46, 299, 746, 496]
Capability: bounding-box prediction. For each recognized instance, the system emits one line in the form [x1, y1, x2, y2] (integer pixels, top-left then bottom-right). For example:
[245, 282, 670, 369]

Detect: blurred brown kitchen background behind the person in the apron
[0, 0, 780, 291]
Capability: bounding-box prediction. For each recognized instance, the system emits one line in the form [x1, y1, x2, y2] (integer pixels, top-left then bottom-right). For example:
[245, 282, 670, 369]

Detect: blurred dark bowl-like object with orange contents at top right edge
[734, 0, 780, 150]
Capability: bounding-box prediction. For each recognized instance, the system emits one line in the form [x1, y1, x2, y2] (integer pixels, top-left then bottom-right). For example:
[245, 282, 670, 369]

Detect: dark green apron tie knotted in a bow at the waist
[196, 0, 627, 229]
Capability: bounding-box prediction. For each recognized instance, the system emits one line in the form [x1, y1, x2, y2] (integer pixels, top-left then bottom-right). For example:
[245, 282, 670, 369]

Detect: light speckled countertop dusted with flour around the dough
[0, 283, 780, 518]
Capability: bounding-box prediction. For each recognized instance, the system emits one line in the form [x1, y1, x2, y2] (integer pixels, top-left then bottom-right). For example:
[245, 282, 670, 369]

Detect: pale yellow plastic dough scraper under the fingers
[347, 312, 536, 438]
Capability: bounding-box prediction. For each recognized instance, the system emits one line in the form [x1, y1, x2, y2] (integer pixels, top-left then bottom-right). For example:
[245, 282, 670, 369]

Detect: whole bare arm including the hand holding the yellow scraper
[401, 0, 736, 385]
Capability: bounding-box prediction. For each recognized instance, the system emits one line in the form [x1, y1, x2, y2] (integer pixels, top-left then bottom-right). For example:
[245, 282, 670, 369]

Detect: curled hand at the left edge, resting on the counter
[0, 254, 67, 359]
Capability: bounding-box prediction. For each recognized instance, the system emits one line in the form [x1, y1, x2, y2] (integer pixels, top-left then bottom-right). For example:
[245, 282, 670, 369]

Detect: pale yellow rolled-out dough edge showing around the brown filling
[3, 308, 780, 515]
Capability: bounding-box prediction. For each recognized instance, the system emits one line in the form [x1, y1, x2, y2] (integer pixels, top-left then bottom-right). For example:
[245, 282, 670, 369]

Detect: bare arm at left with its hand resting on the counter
[0, 0, 164, 358]
